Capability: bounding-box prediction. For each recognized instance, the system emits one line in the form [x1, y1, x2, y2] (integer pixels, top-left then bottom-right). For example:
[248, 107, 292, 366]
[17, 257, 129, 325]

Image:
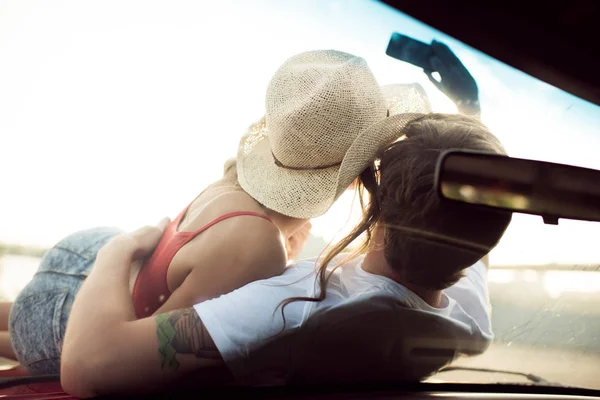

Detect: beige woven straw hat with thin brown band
[237, 50, 430, 218]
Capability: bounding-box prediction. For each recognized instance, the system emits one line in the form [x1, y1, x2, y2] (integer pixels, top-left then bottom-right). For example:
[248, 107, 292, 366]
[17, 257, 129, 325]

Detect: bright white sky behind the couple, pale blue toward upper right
[0, 0, 600, 264]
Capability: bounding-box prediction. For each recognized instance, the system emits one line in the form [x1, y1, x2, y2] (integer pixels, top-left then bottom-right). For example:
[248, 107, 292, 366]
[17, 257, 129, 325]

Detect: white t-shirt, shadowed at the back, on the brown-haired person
[194, 257, 493, 384]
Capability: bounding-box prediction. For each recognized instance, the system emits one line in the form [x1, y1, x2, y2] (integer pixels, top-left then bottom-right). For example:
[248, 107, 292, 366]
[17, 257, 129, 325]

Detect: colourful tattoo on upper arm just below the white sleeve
[155, 308, 221, 369]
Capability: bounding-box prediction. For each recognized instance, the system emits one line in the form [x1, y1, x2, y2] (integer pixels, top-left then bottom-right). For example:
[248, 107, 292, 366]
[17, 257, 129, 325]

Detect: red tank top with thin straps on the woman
[132, 206, 273, 318]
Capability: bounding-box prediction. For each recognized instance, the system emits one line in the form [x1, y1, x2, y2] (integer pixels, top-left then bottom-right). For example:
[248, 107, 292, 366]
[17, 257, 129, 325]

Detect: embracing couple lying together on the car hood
[0, 51, 511, 397]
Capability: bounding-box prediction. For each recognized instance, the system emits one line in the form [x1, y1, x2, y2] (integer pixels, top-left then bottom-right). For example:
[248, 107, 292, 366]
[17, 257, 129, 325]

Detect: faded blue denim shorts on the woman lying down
[9, 228, 121, 375]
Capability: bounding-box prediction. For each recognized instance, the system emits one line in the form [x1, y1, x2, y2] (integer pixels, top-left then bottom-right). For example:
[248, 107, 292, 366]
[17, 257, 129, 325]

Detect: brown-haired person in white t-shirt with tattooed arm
[61, 114, 511, 396]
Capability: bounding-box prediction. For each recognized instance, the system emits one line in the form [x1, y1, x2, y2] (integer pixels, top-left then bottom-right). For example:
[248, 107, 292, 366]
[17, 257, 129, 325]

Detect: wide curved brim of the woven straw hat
[237, 84, 430, 219]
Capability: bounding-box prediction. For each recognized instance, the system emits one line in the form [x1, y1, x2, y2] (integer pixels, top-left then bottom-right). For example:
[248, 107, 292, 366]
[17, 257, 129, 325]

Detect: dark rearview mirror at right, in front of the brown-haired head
[436, 150, 600, 224]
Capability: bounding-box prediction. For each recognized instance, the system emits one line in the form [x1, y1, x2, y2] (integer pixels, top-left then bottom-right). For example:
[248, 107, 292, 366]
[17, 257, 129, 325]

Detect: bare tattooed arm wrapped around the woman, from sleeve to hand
[61, 221, 224, 397]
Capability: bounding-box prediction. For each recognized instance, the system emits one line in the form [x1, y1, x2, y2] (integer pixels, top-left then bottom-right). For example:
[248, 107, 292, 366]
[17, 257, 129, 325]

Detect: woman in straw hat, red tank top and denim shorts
[3, 51, 432, 374]
